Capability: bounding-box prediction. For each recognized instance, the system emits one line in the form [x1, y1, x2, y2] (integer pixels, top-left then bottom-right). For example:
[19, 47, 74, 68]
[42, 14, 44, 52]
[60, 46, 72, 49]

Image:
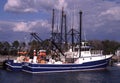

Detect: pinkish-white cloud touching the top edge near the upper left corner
[4, 0, 37, 12]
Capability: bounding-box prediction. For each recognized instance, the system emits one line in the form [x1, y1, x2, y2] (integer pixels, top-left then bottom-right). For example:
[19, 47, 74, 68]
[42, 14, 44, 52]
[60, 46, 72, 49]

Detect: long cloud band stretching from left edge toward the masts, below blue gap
[0, 20, 51, 32]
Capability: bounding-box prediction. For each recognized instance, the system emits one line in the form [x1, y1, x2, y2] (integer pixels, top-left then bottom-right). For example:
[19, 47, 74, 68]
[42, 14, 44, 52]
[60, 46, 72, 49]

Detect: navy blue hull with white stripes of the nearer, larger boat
[22, 59, 109, 73]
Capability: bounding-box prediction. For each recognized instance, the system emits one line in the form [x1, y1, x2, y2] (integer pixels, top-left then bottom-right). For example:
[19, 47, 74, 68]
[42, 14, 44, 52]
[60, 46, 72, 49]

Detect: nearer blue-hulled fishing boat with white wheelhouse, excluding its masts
[22, 42, 112, 73]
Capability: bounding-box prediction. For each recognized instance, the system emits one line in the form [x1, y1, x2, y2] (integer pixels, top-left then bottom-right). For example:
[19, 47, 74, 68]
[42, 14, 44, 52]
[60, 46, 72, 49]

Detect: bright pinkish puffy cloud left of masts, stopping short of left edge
[13, 20, 50, 32]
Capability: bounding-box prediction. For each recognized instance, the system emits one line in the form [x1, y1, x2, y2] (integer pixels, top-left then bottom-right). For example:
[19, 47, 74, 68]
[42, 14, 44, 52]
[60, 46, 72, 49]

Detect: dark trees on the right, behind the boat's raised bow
[89, 40, 120, 54]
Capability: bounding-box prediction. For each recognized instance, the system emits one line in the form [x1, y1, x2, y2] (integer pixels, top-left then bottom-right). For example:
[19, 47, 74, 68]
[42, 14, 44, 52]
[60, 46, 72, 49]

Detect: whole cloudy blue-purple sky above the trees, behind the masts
[0, 0, 120, 42]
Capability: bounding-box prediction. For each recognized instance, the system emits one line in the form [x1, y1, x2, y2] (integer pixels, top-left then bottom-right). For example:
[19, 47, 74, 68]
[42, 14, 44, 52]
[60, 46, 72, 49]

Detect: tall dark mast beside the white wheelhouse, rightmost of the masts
[79, 11, 82, 57]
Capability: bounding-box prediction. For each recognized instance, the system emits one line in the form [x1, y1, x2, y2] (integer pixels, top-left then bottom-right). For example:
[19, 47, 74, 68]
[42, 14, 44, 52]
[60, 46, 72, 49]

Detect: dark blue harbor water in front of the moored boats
[0, 66, 120, 83]
